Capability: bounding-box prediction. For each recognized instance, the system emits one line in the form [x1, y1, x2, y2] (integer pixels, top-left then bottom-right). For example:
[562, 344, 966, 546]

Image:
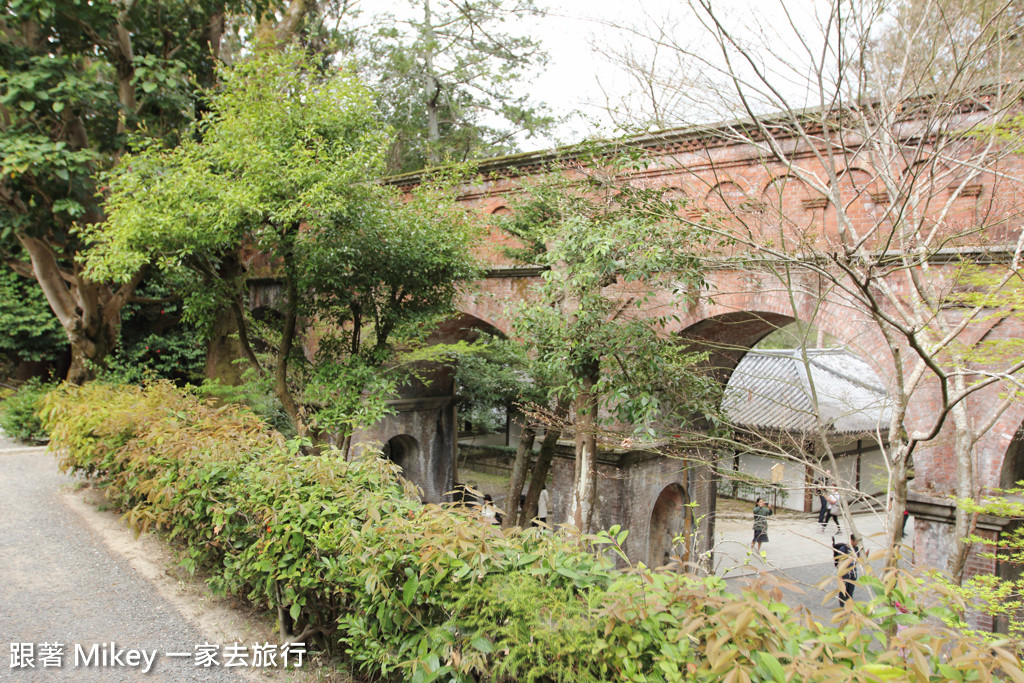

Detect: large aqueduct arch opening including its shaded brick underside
[685, 311, 891, 525]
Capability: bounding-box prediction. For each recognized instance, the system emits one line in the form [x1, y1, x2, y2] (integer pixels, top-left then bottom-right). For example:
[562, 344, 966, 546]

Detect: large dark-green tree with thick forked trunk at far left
[0, 0, 344, 382]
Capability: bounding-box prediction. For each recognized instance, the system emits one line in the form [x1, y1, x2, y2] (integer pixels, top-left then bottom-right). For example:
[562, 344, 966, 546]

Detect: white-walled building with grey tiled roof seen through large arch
[722, 345, 891, 512]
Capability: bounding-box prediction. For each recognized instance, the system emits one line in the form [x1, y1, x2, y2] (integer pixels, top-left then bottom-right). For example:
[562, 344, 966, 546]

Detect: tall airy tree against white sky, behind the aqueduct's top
[362, 0, 553, 171]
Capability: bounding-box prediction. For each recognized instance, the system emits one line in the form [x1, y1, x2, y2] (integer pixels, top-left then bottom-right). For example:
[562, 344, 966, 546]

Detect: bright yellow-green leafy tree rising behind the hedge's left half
[90, 49, 477, 440]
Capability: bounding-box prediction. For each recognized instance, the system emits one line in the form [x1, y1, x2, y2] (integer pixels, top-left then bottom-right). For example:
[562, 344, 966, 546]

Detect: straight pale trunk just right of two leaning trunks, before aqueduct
[569, 360, 599, 533]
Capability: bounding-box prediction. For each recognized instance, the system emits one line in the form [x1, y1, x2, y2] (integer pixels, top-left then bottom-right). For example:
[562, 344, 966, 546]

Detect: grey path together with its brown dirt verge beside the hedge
[0, 441, 347, 683]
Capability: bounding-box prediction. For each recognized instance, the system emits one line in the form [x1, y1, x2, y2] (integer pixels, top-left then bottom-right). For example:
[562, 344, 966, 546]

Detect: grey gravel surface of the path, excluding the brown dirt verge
[0, 446, 245, 683]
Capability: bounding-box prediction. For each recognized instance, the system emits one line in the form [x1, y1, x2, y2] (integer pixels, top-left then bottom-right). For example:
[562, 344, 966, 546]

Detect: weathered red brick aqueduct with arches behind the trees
[348, 117, 1024, 589]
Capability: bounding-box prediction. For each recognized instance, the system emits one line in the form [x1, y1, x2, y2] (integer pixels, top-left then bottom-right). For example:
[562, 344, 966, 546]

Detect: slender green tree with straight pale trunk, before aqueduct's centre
[505, 160, 715, 532]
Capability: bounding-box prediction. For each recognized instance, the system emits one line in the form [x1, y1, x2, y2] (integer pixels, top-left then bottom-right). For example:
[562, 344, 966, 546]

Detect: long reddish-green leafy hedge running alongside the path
[43, 383, 1024, 683]
